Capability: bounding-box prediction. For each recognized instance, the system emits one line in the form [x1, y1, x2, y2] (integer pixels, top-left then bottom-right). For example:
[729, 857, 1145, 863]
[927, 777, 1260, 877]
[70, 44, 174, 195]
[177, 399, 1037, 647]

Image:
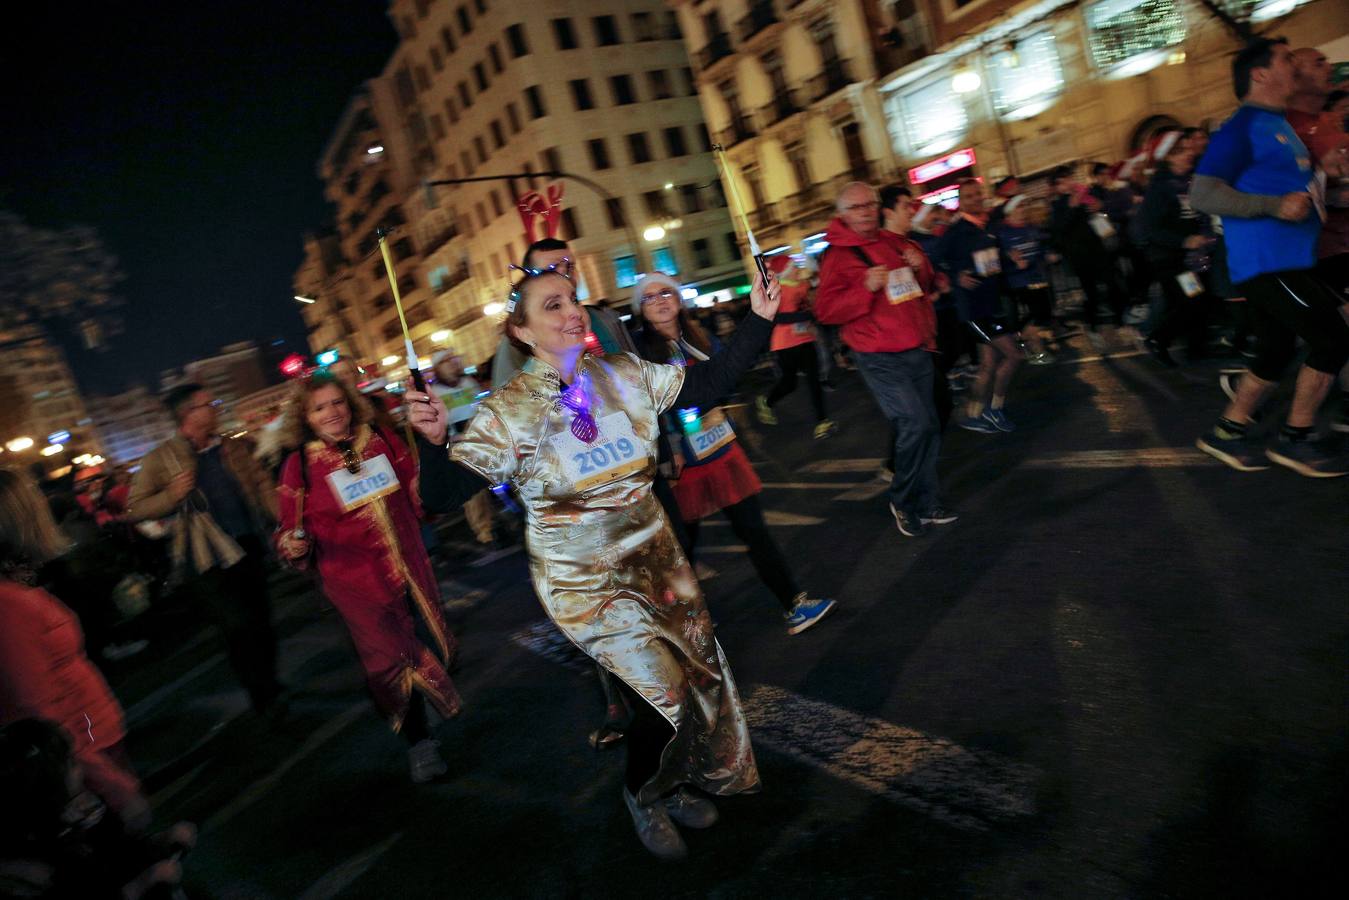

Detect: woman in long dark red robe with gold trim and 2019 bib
[277, 375, 460, 783]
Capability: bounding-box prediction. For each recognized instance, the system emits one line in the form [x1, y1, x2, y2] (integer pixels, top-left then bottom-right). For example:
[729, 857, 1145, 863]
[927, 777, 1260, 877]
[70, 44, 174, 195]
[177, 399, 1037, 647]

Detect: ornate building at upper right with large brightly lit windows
[669, 0, 1349, 251]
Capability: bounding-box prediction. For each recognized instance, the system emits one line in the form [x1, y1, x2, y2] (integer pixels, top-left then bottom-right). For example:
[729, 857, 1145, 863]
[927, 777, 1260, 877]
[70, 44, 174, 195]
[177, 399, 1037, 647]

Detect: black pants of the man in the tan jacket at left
[183, 537, 281, 710]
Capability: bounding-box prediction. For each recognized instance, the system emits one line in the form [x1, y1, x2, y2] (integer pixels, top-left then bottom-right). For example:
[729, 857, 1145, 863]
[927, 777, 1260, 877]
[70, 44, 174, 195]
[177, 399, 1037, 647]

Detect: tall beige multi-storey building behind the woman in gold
[295, 0, 746, 376]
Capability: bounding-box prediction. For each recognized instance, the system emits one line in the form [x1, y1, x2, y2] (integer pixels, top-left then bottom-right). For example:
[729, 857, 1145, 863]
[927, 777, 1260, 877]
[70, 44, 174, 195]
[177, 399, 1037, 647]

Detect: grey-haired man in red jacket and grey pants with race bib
[815, 181, 956, 537]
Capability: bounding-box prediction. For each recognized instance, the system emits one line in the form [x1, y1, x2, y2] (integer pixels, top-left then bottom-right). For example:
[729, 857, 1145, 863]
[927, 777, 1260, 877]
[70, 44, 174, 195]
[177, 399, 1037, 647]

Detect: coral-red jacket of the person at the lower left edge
[0, 579, 146, 819]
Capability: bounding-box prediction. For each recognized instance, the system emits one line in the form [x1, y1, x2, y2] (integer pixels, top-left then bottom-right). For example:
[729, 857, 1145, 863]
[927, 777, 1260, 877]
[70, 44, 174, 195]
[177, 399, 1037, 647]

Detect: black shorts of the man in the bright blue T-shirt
[1236, 269, 1349, 382]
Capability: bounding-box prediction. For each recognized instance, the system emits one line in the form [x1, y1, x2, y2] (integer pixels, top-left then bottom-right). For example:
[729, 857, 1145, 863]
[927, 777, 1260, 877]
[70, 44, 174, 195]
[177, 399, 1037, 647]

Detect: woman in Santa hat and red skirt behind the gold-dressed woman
[633, 273, 834, 634]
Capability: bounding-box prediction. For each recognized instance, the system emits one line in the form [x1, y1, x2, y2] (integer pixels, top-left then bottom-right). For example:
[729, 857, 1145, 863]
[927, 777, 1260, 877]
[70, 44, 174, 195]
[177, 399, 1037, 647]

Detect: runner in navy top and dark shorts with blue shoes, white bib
[935, 178, 1023, 434]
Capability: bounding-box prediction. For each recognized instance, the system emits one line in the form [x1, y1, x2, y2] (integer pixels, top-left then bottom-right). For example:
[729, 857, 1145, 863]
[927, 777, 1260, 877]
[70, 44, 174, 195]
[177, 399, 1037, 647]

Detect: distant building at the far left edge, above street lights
[0, 325, 100, 464]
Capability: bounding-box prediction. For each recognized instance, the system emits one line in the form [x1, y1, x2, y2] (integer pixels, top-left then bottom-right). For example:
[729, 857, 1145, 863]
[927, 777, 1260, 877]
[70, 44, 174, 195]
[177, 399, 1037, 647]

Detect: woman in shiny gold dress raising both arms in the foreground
[407, 270, 778, 860]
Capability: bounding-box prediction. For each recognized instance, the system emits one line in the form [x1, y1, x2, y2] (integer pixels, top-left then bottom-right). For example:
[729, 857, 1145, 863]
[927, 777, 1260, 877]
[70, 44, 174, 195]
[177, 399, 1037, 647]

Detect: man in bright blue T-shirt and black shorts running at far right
[1190, 38, 1349, 478]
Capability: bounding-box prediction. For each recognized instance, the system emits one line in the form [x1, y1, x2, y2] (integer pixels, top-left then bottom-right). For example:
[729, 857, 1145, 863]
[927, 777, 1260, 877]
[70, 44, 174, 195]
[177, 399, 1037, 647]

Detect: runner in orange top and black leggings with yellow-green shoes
[755, 254, 838, 440]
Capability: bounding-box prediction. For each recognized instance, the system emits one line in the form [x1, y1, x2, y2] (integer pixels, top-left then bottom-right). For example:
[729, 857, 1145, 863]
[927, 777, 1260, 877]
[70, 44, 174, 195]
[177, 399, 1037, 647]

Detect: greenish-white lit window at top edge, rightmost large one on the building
[1086, 0, 1184, 77]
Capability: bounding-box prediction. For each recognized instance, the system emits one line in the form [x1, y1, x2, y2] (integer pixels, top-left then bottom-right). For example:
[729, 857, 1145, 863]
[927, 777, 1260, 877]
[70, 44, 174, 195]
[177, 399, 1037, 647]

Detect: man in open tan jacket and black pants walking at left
[127, 383, 285, 718]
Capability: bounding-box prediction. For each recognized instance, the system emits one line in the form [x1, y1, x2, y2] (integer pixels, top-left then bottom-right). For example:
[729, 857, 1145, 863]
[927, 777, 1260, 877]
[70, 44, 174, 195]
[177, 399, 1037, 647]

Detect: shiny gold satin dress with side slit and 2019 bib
[451, 354, 759, 804]
